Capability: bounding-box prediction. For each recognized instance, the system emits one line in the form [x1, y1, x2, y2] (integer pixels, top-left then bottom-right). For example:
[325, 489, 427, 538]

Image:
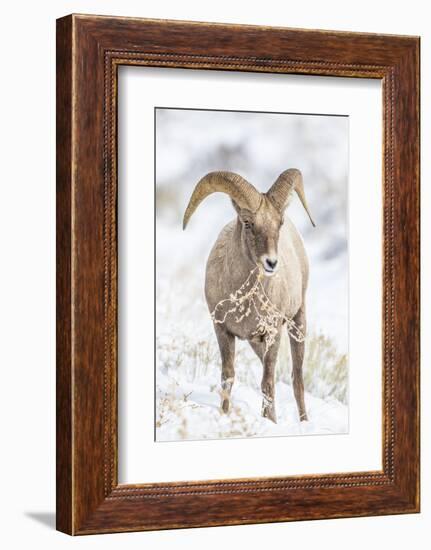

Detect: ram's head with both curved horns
[183, 168, 314, 276]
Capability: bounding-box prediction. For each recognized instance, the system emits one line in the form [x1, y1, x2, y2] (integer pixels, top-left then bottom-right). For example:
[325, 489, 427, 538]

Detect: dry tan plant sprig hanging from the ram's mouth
[211, 266, 305, 354]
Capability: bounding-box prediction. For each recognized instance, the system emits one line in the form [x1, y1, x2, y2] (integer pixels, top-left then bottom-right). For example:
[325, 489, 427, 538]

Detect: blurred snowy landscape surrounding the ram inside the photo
[156, 108, 348, 441]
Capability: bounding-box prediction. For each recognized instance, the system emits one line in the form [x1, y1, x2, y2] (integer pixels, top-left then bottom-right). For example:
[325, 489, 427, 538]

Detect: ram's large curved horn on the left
[183, 172, 262, 229]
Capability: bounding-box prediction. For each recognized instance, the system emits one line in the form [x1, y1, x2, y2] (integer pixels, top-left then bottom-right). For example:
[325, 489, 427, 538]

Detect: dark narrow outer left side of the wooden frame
[56, 19, 73, 533]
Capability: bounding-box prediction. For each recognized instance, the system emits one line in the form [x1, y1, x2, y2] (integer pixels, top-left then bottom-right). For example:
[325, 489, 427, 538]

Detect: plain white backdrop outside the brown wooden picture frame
[0, 0, 431, 549]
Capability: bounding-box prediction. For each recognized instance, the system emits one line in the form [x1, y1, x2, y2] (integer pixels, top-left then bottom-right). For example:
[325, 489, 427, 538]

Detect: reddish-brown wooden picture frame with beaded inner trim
[56, 15, 420, 535]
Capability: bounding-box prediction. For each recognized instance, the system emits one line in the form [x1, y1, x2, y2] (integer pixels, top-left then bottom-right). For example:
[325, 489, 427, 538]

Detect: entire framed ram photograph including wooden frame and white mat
[57, 15, 419, 535]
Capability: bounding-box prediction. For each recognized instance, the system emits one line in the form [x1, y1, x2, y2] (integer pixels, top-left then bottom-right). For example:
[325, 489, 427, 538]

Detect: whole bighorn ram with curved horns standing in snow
[183, 168, 314, 422]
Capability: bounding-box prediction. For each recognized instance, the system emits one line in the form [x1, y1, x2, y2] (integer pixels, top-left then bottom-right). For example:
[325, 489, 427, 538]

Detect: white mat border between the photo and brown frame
[118, 67, 382, 483]
